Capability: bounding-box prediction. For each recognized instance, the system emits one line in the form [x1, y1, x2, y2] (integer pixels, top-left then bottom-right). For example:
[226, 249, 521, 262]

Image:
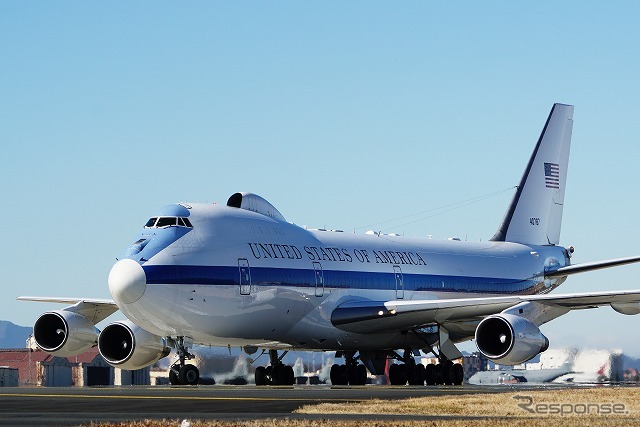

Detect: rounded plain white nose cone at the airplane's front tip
[109, 259, 147, 304]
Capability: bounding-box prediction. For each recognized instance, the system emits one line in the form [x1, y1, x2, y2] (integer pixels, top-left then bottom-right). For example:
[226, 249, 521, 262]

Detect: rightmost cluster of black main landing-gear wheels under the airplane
[389, 350, 464, 385]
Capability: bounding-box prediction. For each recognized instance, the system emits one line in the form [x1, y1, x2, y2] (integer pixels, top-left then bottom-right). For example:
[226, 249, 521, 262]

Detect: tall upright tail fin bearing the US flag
[491, 104, 573, 245]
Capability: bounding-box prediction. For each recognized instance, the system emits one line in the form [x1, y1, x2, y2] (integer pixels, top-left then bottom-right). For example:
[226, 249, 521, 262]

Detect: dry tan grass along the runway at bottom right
[84, 387, 640, 427]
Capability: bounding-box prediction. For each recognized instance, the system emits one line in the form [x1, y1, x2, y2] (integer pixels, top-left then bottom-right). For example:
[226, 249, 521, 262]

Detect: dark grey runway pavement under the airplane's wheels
[0, 385, 588, 426]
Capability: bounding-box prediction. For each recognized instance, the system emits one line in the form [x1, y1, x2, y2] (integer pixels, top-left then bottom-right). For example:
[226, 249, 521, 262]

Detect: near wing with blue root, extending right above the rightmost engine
[331, 290, 640, 333]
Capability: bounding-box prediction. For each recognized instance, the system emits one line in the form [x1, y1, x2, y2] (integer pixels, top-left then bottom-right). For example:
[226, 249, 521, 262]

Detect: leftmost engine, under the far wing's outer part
[33, 310, 100, 357]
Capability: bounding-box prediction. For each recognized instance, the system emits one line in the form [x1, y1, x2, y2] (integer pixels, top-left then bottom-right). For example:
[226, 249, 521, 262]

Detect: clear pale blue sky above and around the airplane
[0, 1, 640, 355]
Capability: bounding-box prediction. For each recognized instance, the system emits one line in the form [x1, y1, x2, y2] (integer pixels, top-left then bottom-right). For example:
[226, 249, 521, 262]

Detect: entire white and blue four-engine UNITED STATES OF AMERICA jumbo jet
[18, 104, 640, 385]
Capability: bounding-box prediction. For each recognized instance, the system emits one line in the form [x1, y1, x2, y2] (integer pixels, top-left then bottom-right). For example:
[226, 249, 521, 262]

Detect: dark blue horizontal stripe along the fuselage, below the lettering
[142, 265, 540, 294]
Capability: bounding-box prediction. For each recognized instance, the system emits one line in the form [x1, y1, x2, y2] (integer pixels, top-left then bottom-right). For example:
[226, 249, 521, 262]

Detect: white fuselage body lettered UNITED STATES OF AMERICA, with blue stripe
[114, 204, 569, 350]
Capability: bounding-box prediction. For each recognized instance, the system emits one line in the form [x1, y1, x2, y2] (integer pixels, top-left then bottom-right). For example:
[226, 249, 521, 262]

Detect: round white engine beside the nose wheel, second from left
[98, 320, 171, 370]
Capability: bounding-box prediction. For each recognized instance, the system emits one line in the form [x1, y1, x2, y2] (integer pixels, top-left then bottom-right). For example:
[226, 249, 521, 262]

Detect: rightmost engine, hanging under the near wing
[476, 314, 549, 365]
